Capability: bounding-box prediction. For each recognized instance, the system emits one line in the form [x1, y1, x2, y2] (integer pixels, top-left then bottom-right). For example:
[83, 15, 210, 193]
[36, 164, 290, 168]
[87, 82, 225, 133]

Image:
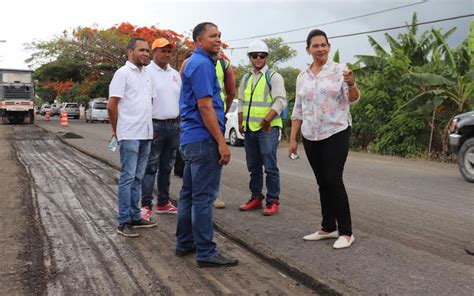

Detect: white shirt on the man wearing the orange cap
[147, 61, 181, 119]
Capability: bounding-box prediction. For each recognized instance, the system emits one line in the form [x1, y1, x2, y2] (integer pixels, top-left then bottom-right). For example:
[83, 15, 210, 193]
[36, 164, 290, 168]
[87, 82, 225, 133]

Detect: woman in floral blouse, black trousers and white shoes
[289, 30, 360, 249]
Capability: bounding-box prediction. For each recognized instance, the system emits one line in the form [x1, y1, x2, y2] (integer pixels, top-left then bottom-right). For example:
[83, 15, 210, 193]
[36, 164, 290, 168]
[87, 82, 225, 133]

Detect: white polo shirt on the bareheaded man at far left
[109, 61, 153, 141]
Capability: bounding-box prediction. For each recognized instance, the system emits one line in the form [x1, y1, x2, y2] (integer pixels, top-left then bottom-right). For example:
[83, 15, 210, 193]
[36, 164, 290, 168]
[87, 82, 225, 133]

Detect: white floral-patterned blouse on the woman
[291, 60, 359, 141]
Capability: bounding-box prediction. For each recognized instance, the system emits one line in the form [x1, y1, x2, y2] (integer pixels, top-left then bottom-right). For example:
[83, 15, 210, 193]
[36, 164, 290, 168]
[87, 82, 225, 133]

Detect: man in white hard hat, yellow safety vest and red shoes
[238, 40, 288, 216]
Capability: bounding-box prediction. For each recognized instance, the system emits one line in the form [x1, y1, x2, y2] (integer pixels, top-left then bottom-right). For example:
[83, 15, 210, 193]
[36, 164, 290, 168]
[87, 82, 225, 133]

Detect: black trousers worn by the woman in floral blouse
[303, 127, 352, 235]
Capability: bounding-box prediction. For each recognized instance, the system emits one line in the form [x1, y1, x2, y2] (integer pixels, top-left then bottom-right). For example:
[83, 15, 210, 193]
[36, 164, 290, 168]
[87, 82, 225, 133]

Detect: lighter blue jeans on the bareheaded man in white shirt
[117, 140, 151, 226]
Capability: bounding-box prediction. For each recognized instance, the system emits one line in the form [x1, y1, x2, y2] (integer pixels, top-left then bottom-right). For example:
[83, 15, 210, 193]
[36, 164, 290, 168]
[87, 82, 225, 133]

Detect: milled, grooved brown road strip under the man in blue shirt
[15, 126, 315, 295]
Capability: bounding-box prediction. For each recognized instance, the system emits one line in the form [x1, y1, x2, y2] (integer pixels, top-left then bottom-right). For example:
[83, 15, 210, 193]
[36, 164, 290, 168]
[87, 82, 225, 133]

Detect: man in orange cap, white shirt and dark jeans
[141, 38, 181, 221]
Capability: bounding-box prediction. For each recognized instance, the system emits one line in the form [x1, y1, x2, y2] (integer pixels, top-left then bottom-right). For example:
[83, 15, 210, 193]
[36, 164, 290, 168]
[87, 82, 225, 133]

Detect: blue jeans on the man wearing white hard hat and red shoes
[244, 127, 280, 204]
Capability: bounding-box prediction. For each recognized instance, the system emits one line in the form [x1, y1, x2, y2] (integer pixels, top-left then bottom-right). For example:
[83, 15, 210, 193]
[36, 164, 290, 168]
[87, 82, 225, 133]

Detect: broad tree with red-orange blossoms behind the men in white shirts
[27, 23, 194, 101]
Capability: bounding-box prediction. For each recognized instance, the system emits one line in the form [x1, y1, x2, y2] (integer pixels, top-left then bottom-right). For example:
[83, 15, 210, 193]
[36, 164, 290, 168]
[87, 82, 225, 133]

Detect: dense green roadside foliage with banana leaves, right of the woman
[351, 14, 473, 156]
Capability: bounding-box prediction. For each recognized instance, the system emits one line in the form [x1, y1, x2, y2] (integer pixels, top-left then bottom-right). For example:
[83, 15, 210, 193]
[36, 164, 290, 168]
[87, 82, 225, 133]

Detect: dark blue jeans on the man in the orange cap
[142, 120, 179, 208]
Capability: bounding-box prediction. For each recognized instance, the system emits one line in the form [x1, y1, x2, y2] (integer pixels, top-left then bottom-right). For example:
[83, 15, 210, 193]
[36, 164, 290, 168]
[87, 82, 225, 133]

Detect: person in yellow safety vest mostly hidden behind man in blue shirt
[179, 51, 236, 209]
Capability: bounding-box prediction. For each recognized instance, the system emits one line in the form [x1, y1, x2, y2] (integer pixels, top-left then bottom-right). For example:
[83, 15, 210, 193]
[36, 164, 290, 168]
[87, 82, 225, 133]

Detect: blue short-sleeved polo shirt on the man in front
[179, 48, 225, 145]
